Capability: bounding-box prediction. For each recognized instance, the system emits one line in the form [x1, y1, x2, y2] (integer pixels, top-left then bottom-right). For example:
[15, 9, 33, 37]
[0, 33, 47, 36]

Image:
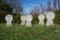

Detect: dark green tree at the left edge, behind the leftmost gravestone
[0, 0, 11, 23]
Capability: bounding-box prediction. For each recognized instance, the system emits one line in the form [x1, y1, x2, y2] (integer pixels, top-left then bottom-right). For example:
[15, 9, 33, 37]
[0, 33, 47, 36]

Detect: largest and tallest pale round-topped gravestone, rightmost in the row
[46, 11, 55, 26]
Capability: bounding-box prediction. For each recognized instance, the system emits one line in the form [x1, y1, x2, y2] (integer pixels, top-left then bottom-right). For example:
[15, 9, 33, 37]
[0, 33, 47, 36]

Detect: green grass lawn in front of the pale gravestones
[0, 24, 60, 40]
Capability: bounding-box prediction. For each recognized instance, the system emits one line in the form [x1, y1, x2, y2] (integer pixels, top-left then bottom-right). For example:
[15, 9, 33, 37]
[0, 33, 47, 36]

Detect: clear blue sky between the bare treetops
[22, 0, 47, 12]
